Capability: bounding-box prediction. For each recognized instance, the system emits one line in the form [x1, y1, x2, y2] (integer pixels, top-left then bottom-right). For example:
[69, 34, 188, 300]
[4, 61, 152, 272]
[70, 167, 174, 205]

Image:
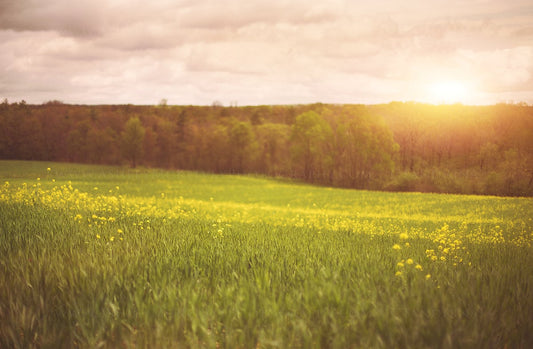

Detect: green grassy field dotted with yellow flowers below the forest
[0, 161, 533, 348]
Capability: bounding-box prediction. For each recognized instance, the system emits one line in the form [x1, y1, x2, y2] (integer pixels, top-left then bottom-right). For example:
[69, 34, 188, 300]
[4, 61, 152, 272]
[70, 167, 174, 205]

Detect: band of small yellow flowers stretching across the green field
[0, 171, 533, 256]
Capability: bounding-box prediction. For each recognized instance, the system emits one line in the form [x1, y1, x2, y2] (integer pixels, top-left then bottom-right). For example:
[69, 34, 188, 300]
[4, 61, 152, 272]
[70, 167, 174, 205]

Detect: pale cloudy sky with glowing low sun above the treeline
[0, 0, 533, 105]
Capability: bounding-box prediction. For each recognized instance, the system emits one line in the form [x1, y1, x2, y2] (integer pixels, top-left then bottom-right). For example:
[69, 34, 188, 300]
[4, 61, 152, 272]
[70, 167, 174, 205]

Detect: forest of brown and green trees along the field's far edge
[0, 100, 533, 196]
